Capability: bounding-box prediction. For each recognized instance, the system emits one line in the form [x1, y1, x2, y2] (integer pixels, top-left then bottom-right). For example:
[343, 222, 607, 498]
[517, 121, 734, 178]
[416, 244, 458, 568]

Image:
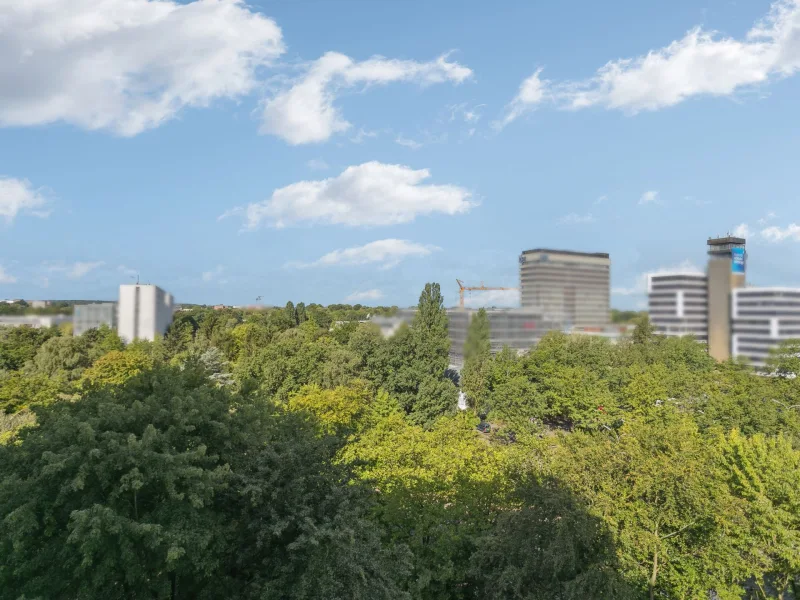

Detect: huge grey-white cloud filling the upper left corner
[0, 0, 284, 136]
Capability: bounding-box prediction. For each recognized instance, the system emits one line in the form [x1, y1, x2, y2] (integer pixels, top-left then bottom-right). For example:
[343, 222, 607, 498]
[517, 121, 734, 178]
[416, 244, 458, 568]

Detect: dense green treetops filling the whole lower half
[0, 284, 800, 600]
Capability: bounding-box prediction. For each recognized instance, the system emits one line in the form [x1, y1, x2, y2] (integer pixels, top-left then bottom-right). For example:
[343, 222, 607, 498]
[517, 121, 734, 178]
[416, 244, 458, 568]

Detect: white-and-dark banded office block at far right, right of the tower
[731, 288, 800, 367]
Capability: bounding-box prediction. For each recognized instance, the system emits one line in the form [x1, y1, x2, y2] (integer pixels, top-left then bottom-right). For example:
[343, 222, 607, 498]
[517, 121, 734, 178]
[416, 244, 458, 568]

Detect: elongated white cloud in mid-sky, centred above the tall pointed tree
[220, 161, 474, 229]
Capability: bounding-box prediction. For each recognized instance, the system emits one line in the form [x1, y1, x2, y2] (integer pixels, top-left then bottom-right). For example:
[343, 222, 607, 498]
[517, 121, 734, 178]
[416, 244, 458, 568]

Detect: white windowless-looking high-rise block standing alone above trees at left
[117, 284, 174, 342]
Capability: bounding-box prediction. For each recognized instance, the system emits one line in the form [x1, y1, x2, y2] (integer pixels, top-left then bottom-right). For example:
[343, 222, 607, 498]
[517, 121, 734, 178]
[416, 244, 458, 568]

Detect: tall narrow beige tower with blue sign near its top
[708, 236, 747, 360]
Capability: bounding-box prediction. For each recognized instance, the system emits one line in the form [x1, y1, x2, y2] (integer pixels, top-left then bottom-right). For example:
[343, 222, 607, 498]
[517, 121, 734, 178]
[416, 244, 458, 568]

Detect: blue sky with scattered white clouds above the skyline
[0, 0, 800, 309]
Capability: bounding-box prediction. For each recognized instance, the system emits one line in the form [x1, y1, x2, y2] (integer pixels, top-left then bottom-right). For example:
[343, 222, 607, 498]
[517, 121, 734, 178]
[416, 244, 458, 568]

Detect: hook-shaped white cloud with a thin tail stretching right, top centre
[261, 52, 472, 145]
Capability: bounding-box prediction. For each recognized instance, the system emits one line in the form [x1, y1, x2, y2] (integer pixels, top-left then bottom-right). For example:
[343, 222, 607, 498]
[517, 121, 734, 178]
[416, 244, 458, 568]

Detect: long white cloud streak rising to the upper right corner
[500, 0, 800, 126]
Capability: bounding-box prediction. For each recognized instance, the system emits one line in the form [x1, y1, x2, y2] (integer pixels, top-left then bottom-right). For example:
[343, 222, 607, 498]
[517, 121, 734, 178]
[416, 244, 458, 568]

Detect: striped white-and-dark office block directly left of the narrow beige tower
[647, 272, 708, 342]
